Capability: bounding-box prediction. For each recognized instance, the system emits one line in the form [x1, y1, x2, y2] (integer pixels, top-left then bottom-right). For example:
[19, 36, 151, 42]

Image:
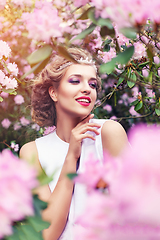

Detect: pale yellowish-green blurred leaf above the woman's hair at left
[27, 44, 53, 65]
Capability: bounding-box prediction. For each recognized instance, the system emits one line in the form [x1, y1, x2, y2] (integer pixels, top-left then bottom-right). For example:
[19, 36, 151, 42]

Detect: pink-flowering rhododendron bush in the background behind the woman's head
[0, 0, 160, 149]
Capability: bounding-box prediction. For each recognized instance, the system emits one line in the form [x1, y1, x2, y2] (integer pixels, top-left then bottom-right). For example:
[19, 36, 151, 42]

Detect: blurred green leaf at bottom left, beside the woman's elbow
[27, 216, 50, 232]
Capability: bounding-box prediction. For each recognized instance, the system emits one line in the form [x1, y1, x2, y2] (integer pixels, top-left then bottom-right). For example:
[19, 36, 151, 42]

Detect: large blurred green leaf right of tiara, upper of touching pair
[116, 46, 134, 65]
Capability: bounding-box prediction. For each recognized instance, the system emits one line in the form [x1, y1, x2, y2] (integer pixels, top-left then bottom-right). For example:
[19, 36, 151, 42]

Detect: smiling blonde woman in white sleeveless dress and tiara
[20, 48, 127, 240]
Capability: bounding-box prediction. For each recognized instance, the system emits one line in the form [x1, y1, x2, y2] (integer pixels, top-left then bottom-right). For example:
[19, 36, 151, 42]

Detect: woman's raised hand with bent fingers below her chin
[68, 114, 101, 161]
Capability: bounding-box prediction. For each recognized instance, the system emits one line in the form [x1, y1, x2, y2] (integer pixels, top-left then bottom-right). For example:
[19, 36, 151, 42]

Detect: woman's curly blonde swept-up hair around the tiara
[31, 48, 101, 127]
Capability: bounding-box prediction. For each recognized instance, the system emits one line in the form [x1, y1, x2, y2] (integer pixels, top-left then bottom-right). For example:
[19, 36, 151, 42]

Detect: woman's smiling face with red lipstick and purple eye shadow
[50, 64, 97, 119]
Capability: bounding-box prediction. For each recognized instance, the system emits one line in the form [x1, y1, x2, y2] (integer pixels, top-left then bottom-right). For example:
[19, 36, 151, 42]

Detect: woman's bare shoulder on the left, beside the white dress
[19, 141, 41, 171]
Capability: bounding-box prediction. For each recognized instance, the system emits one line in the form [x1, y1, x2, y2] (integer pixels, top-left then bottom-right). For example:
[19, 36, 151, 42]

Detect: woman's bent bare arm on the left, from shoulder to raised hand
[20, 115, 100, 240]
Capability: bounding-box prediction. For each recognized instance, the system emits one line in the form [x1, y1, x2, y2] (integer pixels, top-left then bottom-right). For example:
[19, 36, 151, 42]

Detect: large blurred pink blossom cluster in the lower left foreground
[0, 150, 38, 238]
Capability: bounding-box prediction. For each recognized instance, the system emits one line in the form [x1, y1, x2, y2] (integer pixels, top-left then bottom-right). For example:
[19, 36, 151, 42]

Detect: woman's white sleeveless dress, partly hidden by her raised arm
[35, 119, 106, 240]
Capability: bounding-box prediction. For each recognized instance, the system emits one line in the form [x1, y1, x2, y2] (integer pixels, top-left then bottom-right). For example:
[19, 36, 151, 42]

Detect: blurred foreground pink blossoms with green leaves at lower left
[0, 149, 49, 240]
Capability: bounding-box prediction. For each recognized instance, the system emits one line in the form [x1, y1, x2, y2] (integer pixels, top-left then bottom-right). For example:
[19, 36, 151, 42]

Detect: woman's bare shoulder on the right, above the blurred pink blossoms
[101, 120, 128, 156]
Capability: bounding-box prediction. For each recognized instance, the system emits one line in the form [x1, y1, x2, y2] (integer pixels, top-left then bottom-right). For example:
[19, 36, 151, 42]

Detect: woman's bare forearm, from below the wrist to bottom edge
[43, 156, 76, 240]
